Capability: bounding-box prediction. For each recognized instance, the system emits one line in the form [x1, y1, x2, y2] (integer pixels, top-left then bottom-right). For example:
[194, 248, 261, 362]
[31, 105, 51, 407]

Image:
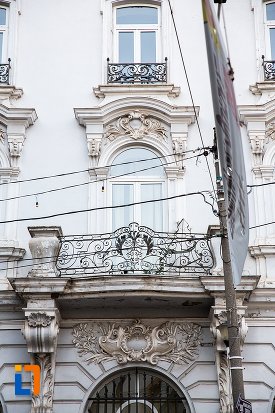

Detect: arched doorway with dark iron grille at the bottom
[86, 368, 190, 413]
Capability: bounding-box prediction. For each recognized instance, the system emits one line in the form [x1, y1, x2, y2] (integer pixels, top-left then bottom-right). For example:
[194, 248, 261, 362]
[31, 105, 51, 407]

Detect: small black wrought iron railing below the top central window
[107, 58, 167, 84]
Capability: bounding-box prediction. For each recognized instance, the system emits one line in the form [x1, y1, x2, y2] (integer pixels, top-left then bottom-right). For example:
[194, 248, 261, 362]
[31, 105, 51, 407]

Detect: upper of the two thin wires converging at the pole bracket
[0, 147, 210, 186]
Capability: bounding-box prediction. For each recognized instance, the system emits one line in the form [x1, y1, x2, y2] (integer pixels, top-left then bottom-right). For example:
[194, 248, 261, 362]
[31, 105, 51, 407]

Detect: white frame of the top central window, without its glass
[113, 3, 161, 63]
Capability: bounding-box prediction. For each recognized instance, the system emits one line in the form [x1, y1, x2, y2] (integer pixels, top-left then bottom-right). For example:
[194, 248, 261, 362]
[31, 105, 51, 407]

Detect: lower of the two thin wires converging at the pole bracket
[0, 151, 208, 202]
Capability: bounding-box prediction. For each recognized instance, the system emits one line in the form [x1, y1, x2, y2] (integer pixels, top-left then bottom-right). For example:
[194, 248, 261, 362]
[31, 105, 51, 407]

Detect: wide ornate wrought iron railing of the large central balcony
[56, 222, 214, 276]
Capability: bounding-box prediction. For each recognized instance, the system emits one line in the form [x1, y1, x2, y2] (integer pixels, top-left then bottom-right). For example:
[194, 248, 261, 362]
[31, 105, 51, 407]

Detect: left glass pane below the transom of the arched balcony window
[112, 184, 134, 230]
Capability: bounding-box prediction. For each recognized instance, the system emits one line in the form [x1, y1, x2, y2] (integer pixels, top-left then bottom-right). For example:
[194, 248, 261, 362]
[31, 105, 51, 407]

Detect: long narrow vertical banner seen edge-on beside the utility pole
[202, 0, 249, 286]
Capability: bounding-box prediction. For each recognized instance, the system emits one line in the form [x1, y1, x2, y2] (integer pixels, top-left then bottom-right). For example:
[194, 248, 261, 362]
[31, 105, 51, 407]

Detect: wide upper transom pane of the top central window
[116, 6, 158, 24]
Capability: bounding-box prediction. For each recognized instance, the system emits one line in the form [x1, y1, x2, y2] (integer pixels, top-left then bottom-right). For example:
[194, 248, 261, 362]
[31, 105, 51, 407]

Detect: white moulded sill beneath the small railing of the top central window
[93, 83, 182, 99]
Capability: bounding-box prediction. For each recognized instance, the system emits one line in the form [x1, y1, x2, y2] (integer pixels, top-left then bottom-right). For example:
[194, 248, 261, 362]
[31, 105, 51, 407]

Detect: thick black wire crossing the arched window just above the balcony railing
[0, 191, 213, 224]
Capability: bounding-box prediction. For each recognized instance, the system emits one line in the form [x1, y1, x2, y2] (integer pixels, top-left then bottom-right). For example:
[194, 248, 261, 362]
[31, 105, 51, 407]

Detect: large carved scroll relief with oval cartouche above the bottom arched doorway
[73, 320, 201, 364]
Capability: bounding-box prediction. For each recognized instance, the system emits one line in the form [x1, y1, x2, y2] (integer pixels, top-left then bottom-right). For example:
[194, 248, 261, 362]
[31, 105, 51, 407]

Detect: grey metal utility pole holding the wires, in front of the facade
[214, 136, 245, 412]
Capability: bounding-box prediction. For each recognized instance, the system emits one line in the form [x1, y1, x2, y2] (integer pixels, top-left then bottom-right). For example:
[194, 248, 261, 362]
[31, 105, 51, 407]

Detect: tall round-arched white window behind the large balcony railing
[109, 147, 165, 231]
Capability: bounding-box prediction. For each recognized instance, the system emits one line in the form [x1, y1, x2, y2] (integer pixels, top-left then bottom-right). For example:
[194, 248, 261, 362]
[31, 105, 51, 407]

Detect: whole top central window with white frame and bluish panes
[114, 5, 160, 63]
